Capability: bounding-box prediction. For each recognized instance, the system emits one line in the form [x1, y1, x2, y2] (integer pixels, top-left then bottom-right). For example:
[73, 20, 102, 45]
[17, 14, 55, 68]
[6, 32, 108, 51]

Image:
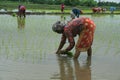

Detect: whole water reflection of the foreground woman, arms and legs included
[54, 56, 91, 80]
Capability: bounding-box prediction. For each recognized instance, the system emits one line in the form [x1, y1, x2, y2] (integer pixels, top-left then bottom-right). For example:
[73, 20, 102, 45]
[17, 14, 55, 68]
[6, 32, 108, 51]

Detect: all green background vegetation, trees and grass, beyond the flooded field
[0, 0, 120, 13]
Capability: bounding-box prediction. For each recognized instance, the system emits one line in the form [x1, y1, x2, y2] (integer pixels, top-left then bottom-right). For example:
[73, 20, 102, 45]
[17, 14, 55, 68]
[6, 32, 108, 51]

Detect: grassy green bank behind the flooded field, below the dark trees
[0, 1, 120, 13]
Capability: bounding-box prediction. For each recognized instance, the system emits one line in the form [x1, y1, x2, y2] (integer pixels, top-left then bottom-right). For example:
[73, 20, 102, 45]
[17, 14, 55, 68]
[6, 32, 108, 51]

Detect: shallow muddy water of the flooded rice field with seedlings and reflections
[0, 15, 120, 80]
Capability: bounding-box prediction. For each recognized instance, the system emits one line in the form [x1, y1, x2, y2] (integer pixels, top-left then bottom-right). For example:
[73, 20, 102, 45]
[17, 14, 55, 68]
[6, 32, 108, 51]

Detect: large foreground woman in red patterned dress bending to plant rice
[52, 17, 96, 59]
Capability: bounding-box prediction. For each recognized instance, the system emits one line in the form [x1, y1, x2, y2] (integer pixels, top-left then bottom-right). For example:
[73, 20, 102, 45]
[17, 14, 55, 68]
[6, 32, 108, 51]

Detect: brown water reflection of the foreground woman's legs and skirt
[74, 57, 91, 80]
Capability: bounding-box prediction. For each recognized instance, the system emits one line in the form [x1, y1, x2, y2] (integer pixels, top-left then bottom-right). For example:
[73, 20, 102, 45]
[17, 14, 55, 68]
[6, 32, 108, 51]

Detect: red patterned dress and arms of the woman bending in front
[59, 17, 96, 51]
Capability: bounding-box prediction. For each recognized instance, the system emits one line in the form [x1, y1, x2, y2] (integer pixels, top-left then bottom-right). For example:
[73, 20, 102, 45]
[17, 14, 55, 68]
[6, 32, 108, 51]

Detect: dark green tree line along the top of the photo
[0, 0, 120, 7]
